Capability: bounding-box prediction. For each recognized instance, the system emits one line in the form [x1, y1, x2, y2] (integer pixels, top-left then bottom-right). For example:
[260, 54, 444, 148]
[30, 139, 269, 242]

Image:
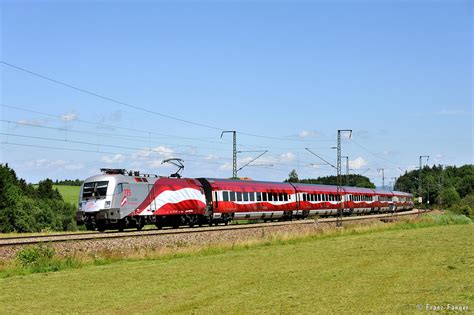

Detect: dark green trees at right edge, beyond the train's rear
[395, 164, 474, 217]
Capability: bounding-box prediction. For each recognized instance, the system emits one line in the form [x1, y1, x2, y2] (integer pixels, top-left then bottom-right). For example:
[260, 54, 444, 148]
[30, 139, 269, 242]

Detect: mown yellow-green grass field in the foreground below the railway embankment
[0, 224, 474, 313]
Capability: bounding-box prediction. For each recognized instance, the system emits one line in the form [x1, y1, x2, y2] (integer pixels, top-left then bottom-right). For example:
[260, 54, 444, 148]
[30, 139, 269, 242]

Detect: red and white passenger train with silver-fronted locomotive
[76, 169, 414, 231]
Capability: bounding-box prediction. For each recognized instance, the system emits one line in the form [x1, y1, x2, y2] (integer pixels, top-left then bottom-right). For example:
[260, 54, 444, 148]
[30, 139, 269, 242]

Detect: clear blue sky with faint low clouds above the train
[0, 0, 474, 186]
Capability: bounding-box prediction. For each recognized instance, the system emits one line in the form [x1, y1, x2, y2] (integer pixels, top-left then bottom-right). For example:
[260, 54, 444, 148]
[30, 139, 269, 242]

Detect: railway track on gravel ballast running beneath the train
[0, 209, 424, 247]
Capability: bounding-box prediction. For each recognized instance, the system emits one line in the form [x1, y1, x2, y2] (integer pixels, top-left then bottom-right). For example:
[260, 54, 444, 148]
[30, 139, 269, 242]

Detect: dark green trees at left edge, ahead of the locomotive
[0, 164, 76, 233]
